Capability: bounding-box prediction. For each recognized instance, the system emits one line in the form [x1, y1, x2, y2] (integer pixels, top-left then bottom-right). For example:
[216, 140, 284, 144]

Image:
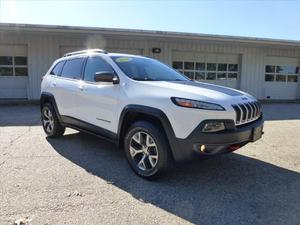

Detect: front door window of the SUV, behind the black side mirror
[84, 56, 113, 82]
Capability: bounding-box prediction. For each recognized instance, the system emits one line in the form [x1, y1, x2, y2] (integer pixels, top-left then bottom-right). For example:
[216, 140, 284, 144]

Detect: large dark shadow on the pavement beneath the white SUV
[47, 133, 300, 225]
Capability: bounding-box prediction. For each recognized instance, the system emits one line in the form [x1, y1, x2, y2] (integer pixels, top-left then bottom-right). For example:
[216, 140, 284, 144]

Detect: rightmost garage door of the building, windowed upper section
[264, 56, 299, 99]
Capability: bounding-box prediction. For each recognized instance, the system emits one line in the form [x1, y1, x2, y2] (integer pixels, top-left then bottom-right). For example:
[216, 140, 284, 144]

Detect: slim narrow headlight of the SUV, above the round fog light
[171, 97, 225, 111]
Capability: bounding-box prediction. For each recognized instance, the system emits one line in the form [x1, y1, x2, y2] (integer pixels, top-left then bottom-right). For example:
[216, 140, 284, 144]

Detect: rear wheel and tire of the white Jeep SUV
[41, 103, 65, 138]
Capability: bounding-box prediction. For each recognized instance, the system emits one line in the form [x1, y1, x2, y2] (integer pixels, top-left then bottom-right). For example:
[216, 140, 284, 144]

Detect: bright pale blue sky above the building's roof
[0, 0, 300, 40]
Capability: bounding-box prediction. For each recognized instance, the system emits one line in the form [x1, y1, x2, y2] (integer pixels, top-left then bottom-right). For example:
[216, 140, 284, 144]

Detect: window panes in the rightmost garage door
[265, 65, 299, 83]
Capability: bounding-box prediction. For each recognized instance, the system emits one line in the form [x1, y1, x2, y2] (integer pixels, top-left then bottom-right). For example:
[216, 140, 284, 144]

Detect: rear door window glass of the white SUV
[61, 58, 84, 80]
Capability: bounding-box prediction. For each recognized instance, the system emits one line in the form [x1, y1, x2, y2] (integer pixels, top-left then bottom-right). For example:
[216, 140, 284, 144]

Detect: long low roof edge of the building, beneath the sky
[0, 23, 300, 47]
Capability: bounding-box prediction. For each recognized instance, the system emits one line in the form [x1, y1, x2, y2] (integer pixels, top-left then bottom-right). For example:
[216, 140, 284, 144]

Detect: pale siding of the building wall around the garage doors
[0, 31, 300, 99]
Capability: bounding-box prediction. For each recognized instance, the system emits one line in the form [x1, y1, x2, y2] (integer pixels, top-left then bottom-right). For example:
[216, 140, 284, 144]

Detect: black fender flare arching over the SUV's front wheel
[118, 104, 182, 160]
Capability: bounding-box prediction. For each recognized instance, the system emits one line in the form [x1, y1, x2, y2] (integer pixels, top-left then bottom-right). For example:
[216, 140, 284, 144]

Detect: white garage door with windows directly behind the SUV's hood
[172, 51, 240, 88]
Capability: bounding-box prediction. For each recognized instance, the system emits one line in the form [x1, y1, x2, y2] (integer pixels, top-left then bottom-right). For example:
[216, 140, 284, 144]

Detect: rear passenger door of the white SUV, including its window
[52, 57, 86, 119]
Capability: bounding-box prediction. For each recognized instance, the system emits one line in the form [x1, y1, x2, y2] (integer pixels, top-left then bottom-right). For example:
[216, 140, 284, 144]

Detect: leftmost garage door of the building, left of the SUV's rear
[0, 44, 28, 99]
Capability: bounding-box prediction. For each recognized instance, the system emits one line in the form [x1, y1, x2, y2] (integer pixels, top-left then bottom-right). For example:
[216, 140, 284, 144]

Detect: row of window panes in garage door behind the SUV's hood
[173, 61, 239, 80]
